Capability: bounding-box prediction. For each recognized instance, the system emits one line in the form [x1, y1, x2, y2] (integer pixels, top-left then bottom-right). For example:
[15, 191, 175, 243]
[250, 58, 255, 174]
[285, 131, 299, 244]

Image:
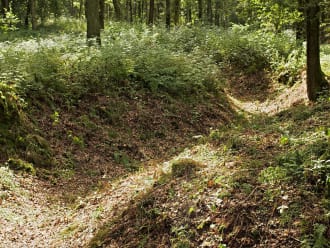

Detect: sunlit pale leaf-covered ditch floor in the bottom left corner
[0, 163, 167, 248]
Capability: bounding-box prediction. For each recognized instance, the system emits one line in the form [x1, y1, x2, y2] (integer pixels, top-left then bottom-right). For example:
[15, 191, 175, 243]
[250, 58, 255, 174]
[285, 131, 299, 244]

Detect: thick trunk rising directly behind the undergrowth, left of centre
[85, 0, 101, 45]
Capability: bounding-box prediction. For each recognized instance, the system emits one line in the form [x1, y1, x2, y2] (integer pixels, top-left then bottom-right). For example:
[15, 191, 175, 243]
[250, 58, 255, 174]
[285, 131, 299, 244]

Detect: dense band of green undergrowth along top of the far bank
[0, 23, 304, 104]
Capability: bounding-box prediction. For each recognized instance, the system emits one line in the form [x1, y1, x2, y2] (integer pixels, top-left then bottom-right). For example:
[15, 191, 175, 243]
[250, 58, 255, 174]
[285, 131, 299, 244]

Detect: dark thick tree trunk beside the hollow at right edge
[306, 0, 327, 101]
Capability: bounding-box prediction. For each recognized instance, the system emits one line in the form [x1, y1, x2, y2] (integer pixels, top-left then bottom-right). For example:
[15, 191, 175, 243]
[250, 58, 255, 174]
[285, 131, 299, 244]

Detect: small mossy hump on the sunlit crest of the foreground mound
[172, 158, 205, 177]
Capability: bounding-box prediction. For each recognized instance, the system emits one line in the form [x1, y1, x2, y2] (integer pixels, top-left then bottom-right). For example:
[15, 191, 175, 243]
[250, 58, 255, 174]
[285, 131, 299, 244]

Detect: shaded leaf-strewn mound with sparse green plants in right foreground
[90, 94, 330, 247]
